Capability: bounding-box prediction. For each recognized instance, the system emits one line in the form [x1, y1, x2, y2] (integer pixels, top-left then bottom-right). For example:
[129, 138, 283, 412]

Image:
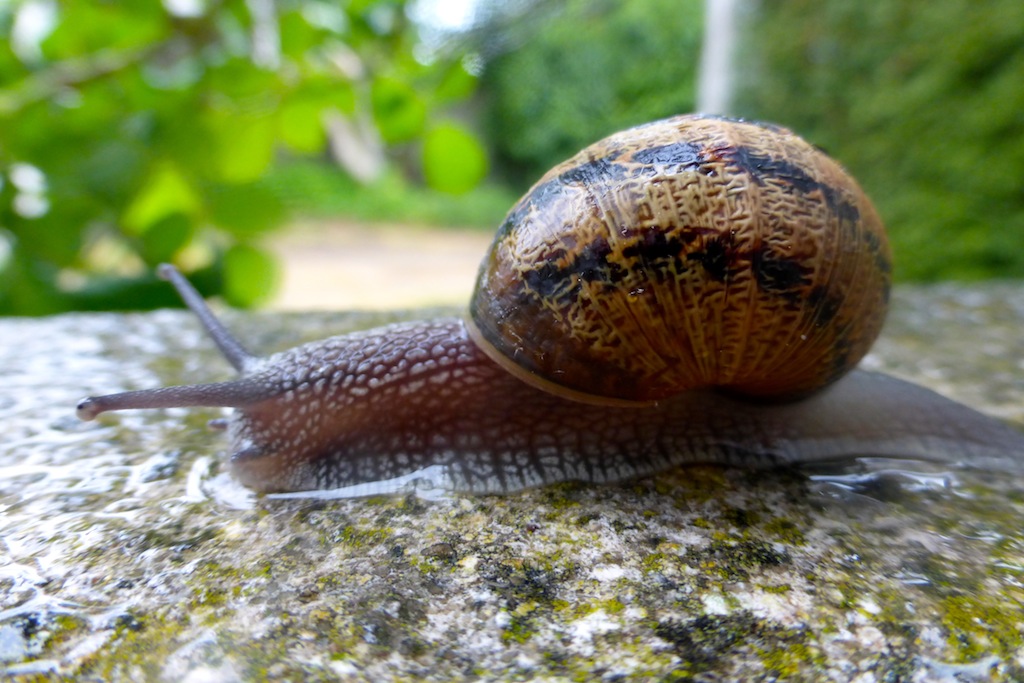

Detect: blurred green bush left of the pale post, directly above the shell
[479, 0, 703, 185]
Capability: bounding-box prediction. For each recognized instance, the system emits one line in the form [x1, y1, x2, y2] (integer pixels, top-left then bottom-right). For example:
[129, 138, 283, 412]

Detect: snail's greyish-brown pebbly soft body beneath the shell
[79, 318, 1024, 493]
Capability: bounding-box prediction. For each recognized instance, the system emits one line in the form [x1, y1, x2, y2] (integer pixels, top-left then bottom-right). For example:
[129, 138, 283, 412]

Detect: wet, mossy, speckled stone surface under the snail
[0, 285, 1024, 682]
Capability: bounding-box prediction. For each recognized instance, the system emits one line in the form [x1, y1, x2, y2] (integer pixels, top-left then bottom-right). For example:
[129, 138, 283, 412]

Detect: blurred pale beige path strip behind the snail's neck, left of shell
[268, 220, 493, 310]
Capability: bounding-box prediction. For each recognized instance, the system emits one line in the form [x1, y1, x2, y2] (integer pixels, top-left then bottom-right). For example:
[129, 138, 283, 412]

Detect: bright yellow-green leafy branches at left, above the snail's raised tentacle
[0, 0, 487, 313]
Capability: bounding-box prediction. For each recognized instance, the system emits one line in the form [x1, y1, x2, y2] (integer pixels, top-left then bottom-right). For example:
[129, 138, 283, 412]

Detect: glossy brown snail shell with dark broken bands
[470, 111, 891, 400]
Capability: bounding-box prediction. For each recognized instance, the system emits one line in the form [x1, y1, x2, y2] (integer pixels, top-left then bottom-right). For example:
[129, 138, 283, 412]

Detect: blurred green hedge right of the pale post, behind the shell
[736, 0, 1024, 280]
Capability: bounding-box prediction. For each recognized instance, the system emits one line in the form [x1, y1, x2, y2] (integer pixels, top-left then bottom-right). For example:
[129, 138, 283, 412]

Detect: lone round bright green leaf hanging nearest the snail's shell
[423, 123, 487, 194]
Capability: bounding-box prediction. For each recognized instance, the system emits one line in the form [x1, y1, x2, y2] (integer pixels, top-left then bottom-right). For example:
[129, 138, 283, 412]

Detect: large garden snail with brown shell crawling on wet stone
[78, 115, 1024, 493]
